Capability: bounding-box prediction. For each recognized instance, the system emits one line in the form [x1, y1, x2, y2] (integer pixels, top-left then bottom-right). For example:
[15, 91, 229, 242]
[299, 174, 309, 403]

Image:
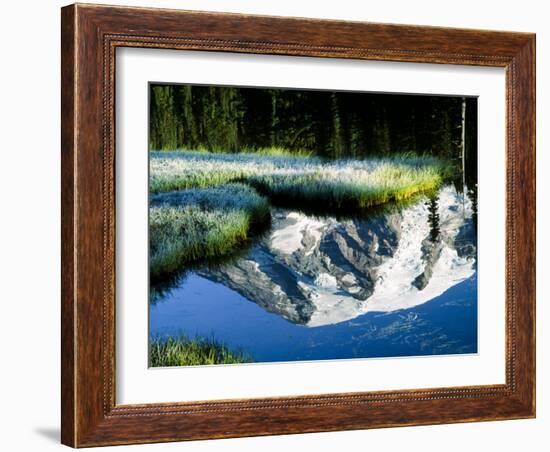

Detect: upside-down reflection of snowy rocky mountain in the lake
[197, 185, 476, 327]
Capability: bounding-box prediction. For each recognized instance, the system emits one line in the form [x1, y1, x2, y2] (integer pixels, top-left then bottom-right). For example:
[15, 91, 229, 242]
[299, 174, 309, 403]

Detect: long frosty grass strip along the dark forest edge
[150, 152, 448, 210]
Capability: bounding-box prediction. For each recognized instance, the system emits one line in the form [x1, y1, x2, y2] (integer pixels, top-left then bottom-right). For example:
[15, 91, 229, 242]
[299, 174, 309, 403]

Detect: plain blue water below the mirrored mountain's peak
[149, 272, 477, 362]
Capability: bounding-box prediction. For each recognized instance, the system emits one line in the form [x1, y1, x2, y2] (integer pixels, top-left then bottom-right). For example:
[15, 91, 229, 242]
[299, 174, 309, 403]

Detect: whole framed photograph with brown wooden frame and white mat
[61, 4, 535, 447]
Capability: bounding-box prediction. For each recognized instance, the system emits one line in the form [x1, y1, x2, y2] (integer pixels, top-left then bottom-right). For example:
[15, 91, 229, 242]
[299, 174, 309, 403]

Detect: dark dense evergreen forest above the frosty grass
[149, 84, 477, 160]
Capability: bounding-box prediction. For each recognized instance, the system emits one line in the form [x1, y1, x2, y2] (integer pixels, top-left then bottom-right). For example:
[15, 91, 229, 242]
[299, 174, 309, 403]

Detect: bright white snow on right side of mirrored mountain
[298, 187, 475, 327]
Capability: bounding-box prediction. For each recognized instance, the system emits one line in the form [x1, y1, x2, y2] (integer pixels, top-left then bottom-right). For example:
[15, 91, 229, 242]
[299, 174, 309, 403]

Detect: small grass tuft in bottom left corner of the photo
[149, 336, 251, 367]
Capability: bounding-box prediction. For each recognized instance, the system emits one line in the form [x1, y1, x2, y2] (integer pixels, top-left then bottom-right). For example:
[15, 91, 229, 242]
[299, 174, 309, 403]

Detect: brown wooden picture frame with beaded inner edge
[61, 4, 535, 447]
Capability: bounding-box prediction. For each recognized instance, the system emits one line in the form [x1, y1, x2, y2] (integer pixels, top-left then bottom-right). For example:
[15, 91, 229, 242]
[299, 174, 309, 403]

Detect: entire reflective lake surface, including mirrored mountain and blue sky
[150, 185, 477, 362]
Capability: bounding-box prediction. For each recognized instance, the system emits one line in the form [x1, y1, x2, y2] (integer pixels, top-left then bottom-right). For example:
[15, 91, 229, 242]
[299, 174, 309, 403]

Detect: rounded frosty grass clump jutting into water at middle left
[149, 183, 271, 283]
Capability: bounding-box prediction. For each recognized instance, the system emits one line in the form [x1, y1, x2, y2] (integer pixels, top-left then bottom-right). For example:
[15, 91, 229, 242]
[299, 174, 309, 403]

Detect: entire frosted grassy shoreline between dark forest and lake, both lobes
[149, 150, 449, 284]
